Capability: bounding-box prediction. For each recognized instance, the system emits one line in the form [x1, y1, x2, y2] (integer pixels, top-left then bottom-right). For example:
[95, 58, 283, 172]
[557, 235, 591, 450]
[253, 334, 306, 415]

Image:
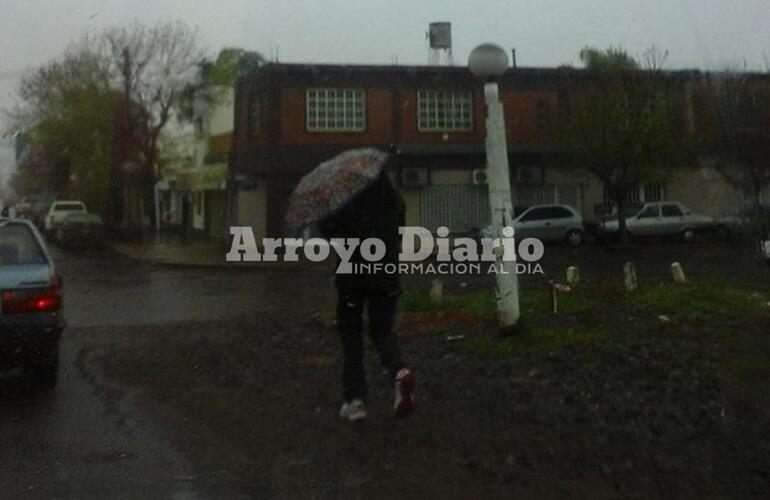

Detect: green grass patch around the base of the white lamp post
[412, 282, 770, 358]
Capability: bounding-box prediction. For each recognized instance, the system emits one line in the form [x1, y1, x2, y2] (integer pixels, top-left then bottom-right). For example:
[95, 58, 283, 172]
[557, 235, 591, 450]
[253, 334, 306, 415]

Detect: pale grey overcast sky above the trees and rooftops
[0, 0, 770, 161]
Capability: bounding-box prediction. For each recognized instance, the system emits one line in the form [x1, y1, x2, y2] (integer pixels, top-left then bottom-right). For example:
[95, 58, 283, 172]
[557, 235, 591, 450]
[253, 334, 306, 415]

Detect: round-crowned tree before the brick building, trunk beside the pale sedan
[568, 48, 688, 243]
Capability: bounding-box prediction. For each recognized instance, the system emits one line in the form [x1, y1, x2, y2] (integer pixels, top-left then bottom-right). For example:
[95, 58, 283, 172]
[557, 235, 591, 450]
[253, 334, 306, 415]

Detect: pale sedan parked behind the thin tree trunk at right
[597, 201, 717, 241]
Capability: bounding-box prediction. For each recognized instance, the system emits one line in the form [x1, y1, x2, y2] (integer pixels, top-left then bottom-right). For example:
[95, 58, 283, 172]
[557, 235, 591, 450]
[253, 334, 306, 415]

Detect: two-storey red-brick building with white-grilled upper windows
[229, 63, 768, 238]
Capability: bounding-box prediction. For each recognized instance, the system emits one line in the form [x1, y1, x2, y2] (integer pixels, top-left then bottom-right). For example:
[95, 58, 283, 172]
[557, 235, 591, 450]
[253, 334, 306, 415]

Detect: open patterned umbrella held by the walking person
[286, 148, 388, 233]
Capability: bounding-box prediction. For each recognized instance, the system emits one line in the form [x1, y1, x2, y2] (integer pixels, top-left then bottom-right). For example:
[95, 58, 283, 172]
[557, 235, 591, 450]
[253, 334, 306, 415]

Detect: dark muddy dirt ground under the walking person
[83, 274, 770, 499]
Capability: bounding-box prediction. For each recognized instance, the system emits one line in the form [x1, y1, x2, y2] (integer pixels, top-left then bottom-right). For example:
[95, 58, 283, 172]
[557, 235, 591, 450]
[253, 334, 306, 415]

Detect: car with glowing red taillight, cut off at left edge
[0, 218, 65, 387]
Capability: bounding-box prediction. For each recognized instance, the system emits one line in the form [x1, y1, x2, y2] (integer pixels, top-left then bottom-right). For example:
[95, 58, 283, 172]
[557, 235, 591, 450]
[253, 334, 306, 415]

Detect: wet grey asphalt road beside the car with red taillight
[0, 245, 331, 499]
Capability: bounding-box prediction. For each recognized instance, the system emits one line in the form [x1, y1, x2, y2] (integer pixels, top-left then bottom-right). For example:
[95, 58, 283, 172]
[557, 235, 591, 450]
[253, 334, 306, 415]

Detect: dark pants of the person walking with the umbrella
[337, 285, 404, 401]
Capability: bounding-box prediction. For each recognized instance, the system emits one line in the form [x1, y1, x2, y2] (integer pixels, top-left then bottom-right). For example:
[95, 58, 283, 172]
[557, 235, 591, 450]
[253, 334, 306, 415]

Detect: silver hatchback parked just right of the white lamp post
[471, 205, 584, 246]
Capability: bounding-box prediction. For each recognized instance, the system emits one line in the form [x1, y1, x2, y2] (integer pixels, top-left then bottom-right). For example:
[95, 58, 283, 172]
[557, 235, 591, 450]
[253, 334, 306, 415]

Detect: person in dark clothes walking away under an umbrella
[319, 170, 415, 422]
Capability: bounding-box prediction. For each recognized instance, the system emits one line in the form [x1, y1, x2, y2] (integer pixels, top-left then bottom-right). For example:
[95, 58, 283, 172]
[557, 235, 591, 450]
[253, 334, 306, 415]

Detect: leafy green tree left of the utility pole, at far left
[11, 43, 119, 214]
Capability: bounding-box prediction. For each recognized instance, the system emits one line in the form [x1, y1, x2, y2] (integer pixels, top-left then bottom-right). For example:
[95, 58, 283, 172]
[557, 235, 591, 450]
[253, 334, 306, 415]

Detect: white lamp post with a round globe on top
[468, 43, 520, 332]
